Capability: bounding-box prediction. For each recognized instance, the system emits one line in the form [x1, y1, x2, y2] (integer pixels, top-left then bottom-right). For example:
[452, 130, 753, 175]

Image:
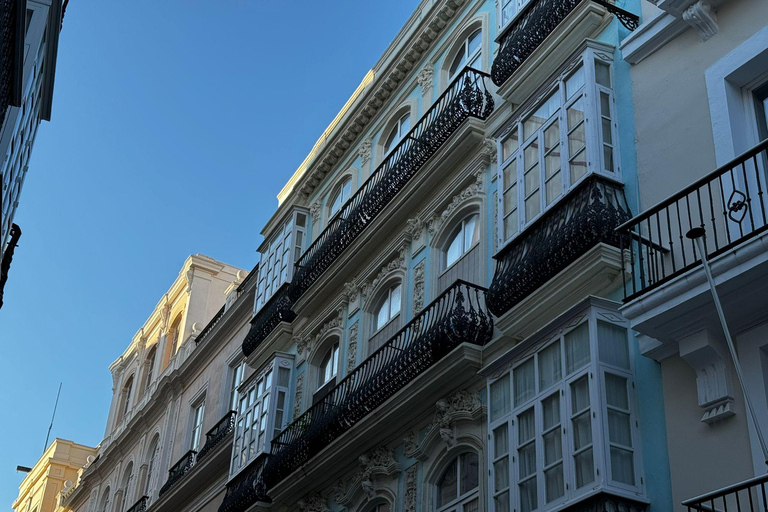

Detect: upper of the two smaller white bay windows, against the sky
[255, 210, 307, 311]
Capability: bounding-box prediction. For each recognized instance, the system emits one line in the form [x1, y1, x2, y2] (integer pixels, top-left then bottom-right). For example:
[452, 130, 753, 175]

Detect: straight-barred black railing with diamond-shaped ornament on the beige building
[618, 140, 768, 301]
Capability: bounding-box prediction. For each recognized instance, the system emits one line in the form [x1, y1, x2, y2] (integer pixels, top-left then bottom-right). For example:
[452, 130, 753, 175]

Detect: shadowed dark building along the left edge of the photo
[0, 0, 64, 306]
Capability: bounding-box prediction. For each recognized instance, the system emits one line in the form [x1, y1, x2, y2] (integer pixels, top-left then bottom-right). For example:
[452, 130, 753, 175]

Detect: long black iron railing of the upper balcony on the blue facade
[291, 67, 493, 300]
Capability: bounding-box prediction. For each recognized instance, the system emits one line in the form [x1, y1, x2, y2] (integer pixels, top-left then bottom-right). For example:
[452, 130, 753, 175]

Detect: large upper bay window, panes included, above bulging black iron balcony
[499, 49, 618, 247]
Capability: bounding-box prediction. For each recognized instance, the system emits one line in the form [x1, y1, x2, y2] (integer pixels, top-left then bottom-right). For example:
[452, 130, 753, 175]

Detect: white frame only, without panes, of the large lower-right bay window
[487, 306, 645, 512]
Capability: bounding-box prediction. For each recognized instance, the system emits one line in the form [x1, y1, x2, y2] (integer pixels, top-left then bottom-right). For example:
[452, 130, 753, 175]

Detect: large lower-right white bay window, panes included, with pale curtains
[488, 304, 645, 512]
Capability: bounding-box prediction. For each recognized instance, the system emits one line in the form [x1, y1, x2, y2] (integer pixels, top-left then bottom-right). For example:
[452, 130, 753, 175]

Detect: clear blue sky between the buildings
[0, 0, 418, 504]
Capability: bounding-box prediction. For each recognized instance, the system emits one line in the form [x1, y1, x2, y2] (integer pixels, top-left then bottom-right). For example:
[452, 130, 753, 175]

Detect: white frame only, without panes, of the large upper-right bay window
[497, 48, 621, 249]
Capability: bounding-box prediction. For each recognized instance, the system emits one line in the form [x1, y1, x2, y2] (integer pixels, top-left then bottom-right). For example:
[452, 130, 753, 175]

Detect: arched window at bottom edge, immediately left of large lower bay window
[435, 452, 480, 512]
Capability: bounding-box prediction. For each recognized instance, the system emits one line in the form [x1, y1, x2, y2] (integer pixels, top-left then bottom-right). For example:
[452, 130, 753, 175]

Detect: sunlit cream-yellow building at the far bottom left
[13, 438, 97, 512]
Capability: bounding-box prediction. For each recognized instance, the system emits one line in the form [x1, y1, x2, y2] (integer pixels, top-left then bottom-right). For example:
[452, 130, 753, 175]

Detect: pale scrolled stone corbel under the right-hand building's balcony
[679, 329, 735, 424]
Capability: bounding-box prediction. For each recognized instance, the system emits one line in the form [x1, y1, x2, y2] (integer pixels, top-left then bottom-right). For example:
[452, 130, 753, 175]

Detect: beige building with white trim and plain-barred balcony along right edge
[621, 0, 768, 510]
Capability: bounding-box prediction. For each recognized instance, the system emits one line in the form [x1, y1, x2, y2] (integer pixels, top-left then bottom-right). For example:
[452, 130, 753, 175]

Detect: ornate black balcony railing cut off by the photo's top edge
[491, 0, 639, 86]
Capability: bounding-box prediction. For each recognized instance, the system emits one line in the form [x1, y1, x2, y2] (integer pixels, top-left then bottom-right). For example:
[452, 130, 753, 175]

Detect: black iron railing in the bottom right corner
[683, 475, 768, 512]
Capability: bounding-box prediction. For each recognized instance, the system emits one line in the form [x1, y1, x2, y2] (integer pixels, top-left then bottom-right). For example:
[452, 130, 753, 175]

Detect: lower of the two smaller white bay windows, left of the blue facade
[230, 357, 293, 476]
